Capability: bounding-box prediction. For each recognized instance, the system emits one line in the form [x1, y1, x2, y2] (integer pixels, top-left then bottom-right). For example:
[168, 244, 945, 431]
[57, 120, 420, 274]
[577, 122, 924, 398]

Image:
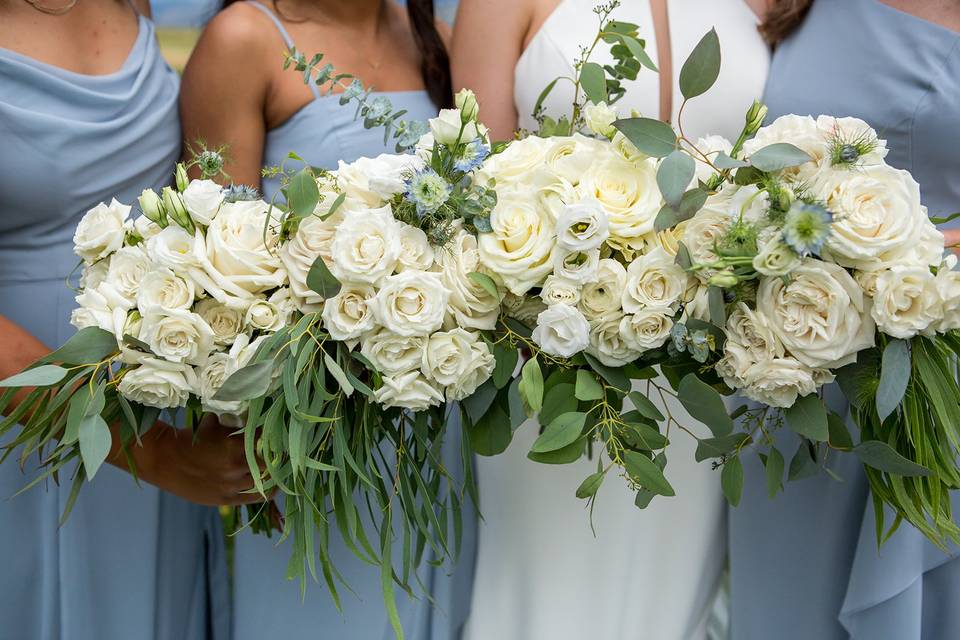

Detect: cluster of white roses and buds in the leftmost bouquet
[71, 180, 294, 414]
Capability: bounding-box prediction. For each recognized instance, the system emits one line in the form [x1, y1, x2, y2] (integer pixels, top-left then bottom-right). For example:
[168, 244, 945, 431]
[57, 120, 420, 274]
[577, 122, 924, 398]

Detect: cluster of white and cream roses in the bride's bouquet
[478, 131, 696, 366]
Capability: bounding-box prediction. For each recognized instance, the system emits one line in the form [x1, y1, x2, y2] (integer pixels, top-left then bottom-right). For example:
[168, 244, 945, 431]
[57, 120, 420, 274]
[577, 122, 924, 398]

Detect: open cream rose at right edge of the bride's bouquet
[621, 247, 688, 313]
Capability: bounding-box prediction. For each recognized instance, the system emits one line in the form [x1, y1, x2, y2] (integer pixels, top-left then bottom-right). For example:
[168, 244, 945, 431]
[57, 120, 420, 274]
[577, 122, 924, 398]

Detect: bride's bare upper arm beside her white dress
[450, 0, 532, 140]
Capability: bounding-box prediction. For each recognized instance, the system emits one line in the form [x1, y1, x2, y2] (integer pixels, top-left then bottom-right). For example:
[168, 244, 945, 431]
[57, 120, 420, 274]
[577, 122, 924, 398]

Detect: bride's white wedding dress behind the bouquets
[463, 0, 769, 640]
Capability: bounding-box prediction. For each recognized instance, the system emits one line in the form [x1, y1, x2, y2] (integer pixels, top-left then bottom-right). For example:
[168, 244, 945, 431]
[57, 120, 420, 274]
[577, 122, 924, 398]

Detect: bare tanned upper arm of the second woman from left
[180, 3, 272, 187]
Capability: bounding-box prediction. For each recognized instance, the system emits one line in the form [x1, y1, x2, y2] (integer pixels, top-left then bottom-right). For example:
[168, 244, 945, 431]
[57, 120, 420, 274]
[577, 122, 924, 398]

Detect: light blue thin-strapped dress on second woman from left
[233, 2, 476, 640]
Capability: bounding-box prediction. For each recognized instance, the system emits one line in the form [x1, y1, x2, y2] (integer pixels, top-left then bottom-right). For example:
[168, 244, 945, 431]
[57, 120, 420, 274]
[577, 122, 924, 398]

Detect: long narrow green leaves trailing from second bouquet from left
[219, 314, 473, 637]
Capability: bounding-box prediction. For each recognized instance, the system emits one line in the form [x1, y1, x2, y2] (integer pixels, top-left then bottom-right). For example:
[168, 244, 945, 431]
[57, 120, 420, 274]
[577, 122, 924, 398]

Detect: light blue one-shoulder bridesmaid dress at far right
[730, 0, 960, 640]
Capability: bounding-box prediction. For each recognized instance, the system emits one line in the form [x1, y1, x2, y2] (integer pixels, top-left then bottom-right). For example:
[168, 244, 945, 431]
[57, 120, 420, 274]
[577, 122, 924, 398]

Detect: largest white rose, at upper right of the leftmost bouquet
[194, 200, 287, 302]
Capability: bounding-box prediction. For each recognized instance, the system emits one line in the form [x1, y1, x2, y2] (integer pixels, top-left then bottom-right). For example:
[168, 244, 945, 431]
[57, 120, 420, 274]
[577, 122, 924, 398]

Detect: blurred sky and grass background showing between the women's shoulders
[150, 0, 457, 71]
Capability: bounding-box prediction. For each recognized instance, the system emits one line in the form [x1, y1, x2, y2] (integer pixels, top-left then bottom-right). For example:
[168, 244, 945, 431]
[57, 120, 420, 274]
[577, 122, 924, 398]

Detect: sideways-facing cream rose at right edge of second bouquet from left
[435, 229, 500, 329]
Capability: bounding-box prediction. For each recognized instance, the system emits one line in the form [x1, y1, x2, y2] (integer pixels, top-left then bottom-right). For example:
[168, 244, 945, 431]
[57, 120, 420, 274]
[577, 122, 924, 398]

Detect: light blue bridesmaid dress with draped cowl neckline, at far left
[0, 17, 229, 640]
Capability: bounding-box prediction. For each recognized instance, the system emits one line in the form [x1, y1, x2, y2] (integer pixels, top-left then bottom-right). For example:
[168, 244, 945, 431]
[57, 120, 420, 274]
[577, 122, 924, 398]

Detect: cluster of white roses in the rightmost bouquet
[708, 115, 960, 407]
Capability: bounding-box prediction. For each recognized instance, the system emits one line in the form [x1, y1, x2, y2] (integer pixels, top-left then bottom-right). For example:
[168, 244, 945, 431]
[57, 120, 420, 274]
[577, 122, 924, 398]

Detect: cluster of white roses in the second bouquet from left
[279, 151, 499, 410]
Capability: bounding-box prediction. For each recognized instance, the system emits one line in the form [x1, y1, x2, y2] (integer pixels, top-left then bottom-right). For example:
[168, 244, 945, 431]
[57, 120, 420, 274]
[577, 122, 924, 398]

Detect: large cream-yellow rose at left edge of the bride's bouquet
[479, 193, 556, 295]
